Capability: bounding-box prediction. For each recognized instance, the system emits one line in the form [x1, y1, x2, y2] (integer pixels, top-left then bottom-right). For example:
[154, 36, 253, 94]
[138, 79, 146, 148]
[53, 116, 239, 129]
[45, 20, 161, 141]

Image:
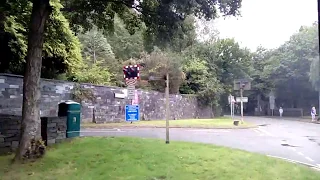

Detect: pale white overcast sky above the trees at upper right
[214, 0, 317, 51]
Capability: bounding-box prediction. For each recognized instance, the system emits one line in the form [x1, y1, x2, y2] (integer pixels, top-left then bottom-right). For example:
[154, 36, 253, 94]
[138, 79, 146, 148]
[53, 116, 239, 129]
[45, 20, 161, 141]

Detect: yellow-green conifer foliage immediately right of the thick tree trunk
[42, 0, 82, 78]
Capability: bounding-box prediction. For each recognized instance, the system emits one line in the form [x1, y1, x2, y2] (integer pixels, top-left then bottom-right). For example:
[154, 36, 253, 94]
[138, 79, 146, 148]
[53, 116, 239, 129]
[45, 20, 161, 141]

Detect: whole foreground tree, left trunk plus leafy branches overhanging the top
[15, 0, 241, 160]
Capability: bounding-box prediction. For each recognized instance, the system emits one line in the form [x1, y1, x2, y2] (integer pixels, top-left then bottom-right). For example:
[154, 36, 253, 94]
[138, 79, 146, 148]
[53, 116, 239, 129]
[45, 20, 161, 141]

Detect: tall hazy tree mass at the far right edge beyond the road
[265, 24, 319, 109]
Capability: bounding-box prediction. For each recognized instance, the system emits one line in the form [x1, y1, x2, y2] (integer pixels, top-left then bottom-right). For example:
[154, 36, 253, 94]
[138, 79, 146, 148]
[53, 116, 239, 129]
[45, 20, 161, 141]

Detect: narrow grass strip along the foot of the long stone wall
[81, 118, 252, 128]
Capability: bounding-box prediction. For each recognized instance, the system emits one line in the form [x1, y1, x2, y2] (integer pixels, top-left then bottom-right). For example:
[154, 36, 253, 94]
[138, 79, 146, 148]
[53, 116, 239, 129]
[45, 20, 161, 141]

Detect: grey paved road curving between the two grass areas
[81, 117, 320, 168]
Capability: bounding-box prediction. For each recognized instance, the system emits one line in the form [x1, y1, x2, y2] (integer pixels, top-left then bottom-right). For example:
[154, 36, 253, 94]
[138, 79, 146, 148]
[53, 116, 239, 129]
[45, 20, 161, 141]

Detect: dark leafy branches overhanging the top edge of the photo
[62, 0, 241, 51]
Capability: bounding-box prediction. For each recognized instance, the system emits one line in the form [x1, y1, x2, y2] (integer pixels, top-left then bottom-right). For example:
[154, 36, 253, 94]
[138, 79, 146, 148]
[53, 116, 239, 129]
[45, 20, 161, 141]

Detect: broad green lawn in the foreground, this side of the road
[0, 137, 320, 180]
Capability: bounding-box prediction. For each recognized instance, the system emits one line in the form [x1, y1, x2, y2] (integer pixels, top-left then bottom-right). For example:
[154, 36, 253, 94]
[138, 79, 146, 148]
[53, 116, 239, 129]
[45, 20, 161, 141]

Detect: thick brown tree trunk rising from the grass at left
[15, 0, 51, 161]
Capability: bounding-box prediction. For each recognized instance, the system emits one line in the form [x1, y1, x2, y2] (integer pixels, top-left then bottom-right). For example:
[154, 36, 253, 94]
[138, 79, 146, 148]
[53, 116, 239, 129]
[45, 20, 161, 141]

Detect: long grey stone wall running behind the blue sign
[0, 74, 213, 122]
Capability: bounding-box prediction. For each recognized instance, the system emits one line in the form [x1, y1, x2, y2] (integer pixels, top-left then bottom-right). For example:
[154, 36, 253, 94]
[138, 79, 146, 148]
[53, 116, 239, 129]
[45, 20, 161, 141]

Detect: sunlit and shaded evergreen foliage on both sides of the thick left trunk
[0, 0, 82, 78]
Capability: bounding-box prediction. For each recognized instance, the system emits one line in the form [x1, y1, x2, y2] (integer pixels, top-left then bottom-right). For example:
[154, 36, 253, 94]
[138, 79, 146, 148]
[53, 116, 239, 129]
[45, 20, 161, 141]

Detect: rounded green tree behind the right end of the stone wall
[180, 38, 252, 114]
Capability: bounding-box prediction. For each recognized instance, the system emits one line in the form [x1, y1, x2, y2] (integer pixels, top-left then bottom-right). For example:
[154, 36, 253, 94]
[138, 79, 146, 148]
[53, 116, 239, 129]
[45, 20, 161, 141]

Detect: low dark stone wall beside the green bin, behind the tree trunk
[0, 114, 67, 154]
